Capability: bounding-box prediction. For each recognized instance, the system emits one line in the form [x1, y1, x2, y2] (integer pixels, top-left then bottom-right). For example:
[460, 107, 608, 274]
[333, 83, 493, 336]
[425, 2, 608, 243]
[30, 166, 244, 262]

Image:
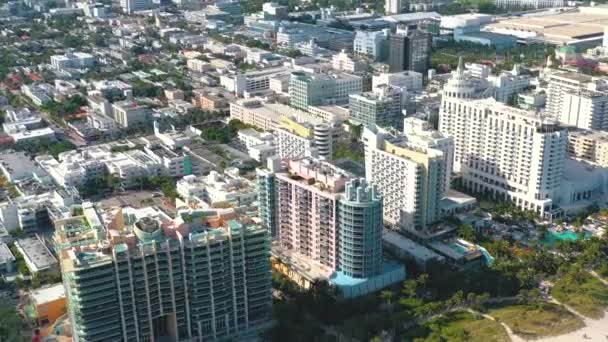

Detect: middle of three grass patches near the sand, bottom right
[488, 303, 585, 339]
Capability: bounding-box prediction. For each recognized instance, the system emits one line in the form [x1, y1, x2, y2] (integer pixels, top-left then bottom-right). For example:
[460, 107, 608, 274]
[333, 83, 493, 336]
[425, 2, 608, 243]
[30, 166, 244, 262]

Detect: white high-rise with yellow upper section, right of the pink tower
[363, 127, 446, 232]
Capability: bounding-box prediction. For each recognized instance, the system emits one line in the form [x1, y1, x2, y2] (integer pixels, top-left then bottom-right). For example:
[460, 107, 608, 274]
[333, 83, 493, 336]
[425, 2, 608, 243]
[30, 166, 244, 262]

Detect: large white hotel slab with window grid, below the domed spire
[439, 97, 568, 216]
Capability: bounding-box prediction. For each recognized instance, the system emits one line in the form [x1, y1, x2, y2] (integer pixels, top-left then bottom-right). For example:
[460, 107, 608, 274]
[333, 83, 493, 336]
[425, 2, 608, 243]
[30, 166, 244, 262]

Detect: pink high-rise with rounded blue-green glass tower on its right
[258, 157, 405, 297]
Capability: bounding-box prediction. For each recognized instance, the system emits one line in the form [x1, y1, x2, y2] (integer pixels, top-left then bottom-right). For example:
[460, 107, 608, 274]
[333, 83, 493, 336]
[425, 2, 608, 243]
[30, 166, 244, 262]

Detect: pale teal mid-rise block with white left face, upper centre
[289, 72, 363, 110]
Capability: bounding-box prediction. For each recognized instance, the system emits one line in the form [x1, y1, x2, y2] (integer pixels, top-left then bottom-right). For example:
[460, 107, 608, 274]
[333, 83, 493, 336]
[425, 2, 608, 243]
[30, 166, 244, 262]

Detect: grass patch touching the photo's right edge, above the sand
[551, 274, 608, 319]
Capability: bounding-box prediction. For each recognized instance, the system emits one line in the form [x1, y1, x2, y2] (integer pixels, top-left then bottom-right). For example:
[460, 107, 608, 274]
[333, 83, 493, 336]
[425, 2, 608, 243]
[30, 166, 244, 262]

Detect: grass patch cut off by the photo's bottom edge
[405, 311, 510, 342]
